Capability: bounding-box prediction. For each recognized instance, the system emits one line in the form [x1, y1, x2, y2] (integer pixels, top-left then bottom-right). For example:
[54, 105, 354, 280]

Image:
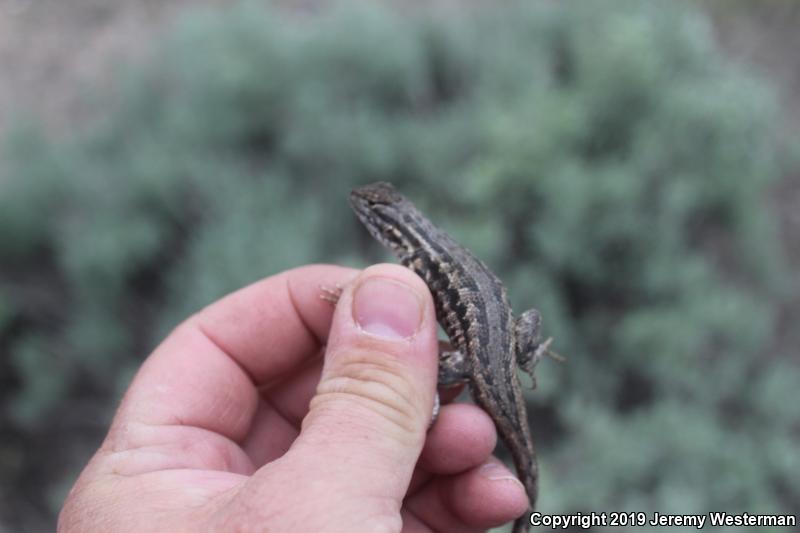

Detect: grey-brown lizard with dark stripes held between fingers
[350, 182, 552, 533]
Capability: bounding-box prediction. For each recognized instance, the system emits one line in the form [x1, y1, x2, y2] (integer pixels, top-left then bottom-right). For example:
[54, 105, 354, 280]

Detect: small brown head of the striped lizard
[350, 182, 414, 256]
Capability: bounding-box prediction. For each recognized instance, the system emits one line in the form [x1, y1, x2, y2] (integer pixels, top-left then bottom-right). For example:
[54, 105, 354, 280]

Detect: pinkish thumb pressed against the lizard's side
[292, 264, 438, 504]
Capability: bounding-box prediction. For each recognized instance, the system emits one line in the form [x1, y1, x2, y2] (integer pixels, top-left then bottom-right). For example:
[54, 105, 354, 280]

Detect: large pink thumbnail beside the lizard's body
[353, 278, 422, 340]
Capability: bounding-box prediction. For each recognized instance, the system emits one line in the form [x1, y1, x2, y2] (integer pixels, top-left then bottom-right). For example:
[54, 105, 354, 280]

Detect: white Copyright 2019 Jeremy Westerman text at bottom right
[530, 512, 797, 529]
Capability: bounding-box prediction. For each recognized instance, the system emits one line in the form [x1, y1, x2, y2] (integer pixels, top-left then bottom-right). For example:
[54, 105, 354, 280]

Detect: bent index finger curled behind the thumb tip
[117, 265, 358, 441]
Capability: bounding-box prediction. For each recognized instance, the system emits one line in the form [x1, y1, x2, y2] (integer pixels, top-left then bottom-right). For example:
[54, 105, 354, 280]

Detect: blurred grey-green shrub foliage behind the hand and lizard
[0, 1, 800, 528]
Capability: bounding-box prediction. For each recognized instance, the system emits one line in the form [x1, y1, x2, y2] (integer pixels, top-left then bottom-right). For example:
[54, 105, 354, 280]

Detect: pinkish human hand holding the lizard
[58, 265, 527, 533]
